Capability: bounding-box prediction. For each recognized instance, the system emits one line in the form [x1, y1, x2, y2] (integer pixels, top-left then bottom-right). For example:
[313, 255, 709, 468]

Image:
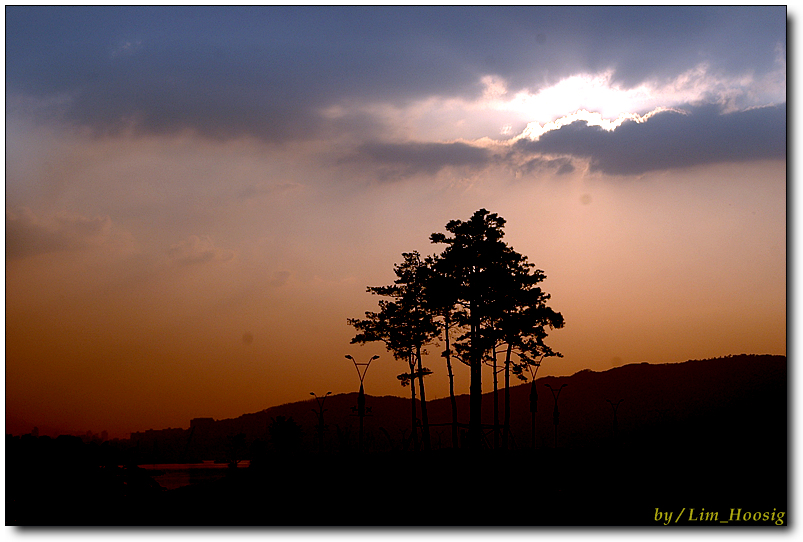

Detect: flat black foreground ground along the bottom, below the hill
[6, 442, 788, 527]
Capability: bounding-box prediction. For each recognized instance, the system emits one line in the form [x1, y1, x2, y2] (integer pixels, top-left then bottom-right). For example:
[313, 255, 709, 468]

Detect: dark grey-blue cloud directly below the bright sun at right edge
[515, 104, 786, 175]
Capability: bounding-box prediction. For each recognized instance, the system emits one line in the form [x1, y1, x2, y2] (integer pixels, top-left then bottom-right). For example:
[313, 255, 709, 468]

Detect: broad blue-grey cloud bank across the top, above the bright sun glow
[6, 6, 786, 141]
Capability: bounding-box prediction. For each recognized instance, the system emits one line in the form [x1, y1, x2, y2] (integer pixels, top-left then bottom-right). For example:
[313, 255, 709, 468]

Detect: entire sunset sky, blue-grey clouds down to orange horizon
[5, 6, 787, 437]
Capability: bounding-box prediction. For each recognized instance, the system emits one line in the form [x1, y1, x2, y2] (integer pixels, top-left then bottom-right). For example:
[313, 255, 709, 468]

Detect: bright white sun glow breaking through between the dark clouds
[376, 58, 786, 146]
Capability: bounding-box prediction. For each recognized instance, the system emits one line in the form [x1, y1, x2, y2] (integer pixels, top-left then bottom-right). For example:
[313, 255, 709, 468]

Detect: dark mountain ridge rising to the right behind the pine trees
[131, 355, 787, 460]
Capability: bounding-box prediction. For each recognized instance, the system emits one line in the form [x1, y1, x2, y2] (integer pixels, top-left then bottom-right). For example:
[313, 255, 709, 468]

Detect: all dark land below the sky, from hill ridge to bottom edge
[7, 356, 789, 528]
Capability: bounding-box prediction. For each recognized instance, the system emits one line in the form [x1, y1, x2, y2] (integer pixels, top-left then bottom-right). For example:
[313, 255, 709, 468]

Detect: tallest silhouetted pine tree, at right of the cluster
[430, 209, 563, 448]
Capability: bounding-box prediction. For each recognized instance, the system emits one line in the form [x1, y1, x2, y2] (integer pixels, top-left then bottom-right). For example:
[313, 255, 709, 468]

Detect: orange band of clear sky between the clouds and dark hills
[6, 143, 786, 440]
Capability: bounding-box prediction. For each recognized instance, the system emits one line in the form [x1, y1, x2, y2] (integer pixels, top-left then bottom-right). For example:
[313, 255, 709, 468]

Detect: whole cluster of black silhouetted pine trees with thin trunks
[348, 209, 564, 448]
